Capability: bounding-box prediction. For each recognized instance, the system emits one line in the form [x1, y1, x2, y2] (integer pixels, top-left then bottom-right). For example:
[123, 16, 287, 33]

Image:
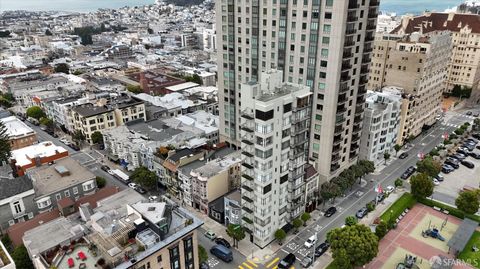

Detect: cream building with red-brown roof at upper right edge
[391, 13, 480, 91]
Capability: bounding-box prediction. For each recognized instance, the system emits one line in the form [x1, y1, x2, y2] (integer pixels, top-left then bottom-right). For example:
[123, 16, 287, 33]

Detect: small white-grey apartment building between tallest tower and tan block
[360, 91, 402, 163]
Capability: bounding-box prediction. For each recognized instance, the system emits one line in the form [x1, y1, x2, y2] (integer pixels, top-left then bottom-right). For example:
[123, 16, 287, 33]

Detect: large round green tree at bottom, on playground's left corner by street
[327, 224, 378, 268]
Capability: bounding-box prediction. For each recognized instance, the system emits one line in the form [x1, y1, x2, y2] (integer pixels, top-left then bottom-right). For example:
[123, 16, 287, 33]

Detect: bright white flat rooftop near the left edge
[10, 141, 68, 166]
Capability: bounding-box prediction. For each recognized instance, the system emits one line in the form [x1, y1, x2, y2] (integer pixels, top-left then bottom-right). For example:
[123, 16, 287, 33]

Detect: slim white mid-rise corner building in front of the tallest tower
[240, 70, 313, 248]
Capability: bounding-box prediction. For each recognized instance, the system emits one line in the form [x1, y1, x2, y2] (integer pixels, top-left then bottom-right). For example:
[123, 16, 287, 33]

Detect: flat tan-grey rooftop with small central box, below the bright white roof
[27, 157, 95, 197]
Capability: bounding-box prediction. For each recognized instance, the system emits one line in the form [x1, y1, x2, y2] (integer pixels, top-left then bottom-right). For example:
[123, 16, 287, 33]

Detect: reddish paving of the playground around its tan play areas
[365, 204, 471, 269]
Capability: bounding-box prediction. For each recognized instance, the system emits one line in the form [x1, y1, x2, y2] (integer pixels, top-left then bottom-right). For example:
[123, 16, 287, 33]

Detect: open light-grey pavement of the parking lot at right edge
[433, 139, 480, 205]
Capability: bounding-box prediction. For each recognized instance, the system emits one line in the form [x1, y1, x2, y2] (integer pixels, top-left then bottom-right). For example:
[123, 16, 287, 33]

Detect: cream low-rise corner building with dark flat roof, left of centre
[67, 96, 146, 143]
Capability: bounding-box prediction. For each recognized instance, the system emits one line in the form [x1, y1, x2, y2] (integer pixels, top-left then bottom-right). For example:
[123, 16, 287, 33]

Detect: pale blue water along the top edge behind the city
[0, 0, 463, 14]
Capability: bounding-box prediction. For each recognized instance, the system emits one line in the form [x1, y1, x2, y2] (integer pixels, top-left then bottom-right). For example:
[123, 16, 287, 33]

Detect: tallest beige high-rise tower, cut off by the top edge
[216, 0, 379, 181]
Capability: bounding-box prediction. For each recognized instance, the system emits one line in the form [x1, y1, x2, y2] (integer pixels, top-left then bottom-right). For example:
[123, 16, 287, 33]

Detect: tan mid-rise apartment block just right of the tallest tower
[368, 31, 452, 144]
